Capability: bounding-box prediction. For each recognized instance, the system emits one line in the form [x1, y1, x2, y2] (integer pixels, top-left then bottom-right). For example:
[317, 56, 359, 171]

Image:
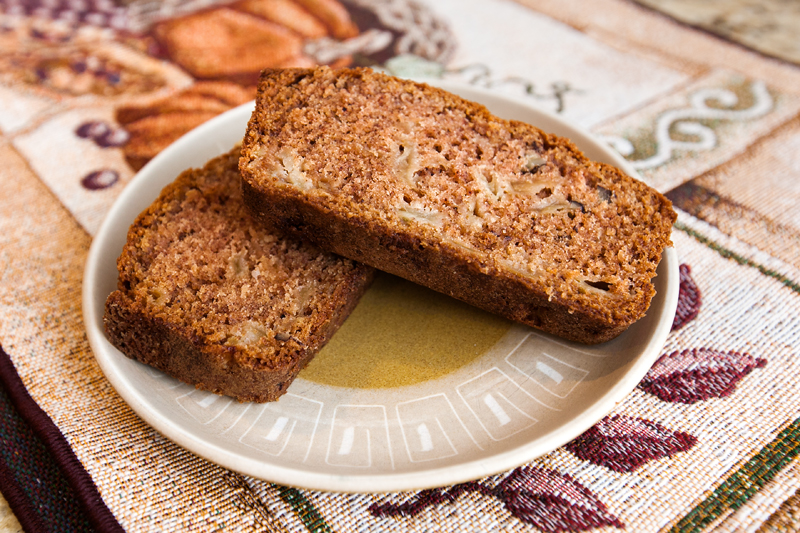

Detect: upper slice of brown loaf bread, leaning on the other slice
[240, 67, 676, 343]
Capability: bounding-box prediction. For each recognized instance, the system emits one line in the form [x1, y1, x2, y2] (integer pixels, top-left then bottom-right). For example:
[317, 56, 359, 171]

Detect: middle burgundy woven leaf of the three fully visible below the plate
[566, 415, 697, 472]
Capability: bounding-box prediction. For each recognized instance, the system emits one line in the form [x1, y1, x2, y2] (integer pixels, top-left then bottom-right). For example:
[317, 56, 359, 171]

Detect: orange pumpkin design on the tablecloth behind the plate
[116, 0, 366, 170]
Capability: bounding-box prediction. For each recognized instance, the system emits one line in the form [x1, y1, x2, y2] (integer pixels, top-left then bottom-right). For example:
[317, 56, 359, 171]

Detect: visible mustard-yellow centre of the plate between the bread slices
[300, 273, 511, 389]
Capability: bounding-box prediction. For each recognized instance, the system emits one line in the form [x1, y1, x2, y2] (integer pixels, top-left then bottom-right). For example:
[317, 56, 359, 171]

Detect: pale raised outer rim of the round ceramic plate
[82, 80, 679, 493]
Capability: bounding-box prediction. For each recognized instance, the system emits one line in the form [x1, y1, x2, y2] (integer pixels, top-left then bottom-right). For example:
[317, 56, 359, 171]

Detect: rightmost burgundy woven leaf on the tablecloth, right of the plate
[639, 348, 767, 404]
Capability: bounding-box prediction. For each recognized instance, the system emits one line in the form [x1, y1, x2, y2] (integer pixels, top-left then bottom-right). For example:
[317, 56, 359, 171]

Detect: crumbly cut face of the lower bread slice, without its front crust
[117, 149, 369, 369]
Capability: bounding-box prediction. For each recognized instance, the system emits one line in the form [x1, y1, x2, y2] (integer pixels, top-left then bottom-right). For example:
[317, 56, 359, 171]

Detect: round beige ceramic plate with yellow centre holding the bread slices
[83, 82, 679, 492]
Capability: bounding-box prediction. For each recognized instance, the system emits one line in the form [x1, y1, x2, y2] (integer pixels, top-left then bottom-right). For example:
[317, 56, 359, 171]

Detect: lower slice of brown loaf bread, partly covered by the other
[104, 148, 373, 402]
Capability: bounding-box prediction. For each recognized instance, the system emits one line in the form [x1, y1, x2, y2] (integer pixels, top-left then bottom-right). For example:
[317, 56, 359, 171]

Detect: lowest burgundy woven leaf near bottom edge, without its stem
[496, 466, 625, 533]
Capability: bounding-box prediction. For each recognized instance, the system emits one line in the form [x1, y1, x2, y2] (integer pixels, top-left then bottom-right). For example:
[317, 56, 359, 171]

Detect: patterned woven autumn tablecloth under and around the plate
[0, 0, 800, 532]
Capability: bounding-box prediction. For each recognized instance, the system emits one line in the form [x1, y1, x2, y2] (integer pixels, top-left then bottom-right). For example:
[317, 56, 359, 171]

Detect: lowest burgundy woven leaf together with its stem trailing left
[369, 466, 625, 533]
